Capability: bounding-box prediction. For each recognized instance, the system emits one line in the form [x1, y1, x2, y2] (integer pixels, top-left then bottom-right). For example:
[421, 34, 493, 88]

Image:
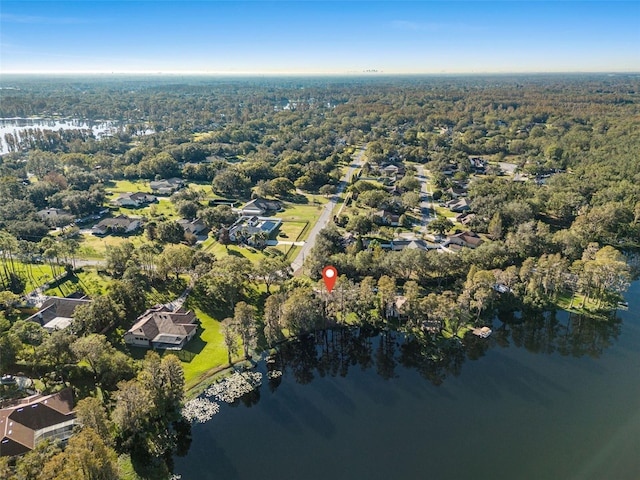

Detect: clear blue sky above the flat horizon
[0, 0, 640, 74]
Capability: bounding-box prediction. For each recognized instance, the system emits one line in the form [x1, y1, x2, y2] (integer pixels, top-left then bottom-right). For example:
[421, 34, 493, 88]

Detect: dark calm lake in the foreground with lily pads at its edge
[174, 282, 640, 480]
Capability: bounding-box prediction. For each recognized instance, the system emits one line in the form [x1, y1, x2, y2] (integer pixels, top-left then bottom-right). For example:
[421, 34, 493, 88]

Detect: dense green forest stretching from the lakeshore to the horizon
[0, 75, 640, 479]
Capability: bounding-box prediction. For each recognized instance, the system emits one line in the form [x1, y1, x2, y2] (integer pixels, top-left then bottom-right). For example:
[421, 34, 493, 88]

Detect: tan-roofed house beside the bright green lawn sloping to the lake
[124, 305, 198, 350]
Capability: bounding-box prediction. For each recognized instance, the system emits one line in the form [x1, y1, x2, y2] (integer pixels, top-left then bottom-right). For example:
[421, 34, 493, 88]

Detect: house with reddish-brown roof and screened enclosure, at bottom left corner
[0, 388, 76, 457]
